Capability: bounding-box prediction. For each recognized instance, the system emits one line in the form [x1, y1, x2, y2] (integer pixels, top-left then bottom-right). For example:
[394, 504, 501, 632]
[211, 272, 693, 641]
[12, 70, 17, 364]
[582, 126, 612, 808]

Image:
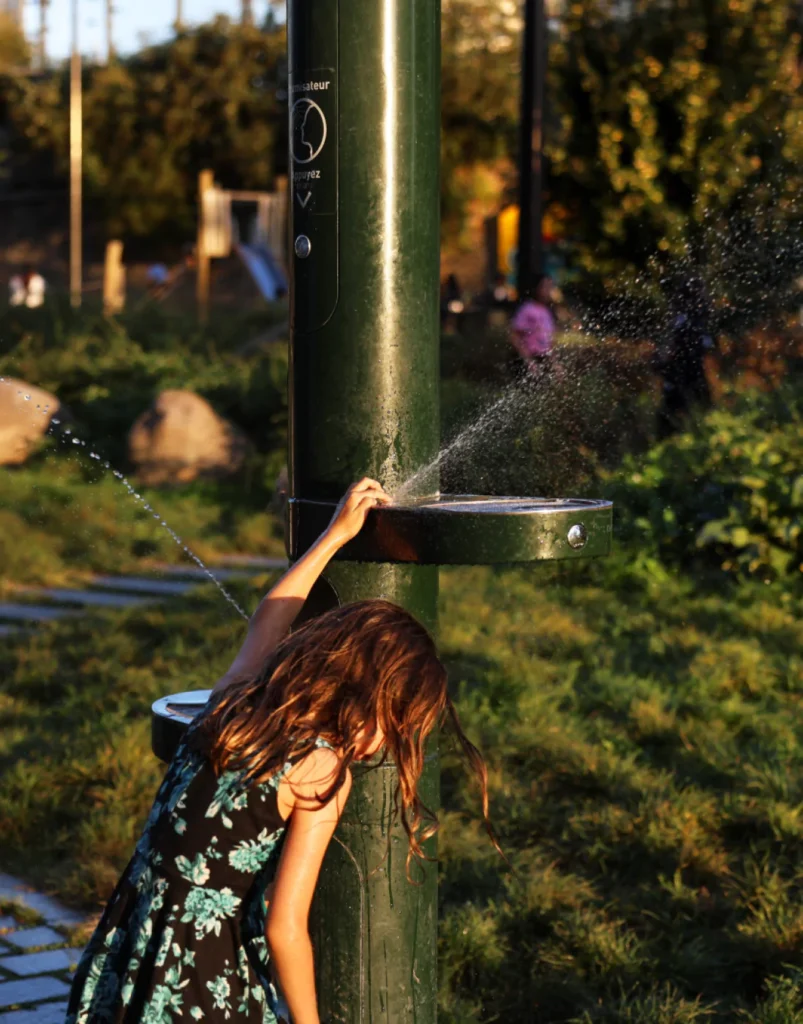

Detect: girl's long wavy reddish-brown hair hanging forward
[191, 600, 498, 871]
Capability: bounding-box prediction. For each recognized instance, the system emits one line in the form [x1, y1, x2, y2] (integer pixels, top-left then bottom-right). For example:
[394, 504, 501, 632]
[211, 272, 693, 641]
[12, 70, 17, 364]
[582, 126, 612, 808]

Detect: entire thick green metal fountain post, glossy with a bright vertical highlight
[288, 0, 440, 1024]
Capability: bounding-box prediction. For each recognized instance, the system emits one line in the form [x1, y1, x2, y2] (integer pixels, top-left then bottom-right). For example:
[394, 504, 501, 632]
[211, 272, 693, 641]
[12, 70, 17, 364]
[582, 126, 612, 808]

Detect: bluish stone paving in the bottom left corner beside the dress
[0, 873, 85, 1024]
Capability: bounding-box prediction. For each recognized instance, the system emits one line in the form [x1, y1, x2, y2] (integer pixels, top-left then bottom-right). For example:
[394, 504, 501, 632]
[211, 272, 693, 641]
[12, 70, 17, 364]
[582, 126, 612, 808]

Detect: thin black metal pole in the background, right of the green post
[518, 0, 547, 296]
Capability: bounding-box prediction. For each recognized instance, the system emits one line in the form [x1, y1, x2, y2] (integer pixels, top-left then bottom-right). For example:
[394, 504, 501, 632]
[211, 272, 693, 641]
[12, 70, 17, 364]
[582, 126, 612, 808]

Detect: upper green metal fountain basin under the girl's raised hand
[288, 495, 614, 565]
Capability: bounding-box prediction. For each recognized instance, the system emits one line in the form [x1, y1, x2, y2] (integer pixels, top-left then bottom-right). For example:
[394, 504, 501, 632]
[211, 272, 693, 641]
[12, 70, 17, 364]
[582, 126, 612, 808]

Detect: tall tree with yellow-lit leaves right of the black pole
[548, 0, 803, 307]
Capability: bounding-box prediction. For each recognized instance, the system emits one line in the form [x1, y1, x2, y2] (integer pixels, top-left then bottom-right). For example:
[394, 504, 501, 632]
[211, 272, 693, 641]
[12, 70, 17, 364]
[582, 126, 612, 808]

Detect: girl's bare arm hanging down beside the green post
[265, 750, 351, 1024]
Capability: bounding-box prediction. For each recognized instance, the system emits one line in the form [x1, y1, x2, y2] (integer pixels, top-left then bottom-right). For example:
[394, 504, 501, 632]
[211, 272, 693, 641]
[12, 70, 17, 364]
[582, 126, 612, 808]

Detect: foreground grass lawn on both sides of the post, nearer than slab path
[0, 556, 803, 1024]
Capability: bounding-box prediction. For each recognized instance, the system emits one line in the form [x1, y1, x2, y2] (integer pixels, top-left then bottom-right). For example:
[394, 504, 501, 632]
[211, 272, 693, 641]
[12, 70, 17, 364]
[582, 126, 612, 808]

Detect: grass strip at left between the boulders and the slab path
[0, 446, 284, 593]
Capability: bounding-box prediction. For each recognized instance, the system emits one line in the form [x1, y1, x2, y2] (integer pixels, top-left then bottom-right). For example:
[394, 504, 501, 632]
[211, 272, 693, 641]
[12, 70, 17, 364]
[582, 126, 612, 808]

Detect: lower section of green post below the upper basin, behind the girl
[310, 562, 439, 1024]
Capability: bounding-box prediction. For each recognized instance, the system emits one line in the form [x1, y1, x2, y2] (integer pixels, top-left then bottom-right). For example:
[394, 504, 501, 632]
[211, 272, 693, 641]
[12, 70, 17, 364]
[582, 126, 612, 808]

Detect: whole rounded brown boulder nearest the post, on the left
[128, 391, 248, 484]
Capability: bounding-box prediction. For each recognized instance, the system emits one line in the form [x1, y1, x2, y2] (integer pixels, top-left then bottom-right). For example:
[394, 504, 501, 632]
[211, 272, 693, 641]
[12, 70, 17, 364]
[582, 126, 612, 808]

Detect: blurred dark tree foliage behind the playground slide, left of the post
[4, 18, 286, 237]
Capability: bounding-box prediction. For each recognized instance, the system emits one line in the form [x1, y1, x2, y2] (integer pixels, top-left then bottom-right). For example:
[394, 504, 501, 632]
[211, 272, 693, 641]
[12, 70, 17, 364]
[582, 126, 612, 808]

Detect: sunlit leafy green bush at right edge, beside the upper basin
[606, 384, 803, 579]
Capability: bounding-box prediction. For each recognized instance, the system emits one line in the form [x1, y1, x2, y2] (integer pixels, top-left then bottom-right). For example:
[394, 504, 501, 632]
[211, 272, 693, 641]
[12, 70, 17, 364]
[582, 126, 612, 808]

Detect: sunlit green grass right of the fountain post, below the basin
[440, 566, 803, 1024]
